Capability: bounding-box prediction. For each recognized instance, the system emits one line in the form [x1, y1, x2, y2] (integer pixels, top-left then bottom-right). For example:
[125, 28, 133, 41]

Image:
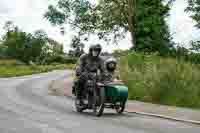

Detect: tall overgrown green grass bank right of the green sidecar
[120, 54, 200, 108]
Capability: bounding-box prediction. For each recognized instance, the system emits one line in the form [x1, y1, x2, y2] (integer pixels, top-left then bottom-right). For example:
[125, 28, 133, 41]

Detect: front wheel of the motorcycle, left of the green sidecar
[93, 87, 105, 117]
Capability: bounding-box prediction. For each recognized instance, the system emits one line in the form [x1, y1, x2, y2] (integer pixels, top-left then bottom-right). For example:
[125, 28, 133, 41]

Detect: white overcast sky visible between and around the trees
[0, 0, 200, 52]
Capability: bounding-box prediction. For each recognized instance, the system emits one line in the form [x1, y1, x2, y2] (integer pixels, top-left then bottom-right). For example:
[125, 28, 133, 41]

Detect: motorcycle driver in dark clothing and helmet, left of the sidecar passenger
[72, 44, 104, 104]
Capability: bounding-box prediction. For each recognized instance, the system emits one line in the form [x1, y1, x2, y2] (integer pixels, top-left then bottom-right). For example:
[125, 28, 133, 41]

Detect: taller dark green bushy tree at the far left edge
[1, 21, 47, 64]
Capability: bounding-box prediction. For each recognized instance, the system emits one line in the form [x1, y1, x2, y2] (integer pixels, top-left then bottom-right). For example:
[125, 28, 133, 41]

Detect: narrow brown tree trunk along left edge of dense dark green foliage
[128, 0, 136, 50]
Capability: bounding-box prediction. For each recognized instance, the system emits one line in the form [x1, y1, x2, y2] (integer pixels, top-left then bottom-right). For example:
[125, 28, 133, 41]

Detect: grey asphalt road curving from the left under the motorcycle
[0, 71, 200, 133]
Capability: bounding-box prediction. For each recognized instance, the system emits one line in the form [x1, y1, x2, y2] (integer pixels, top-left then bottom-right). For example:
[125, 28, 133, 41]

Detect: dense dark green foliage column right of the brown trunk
[136, 0, 172, 53]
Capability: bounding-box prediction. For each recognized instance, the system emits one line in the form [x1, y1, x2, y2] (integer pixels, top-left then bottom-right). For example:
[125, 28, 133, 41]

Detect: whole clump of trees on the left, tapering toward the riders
[0, 21, 63, 64]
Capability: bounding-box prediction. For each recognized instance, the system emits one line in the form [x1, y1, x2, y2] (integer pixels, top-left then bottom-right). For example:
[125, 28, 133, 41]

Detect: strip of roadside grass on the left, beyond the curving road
[0, 60, 75, 77]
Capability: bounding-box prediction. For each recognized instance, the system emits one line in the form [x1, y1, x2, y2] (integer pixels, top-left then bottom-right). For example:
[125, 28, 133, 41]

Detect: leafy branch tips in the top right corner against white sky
[185, 0, 200, 28]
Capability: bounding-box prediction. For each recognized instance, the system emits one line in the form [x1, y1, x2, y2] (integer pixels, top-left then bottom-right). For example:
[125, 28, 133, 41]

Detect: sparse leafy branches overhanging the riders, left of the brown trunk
[44, 0, 127, 44]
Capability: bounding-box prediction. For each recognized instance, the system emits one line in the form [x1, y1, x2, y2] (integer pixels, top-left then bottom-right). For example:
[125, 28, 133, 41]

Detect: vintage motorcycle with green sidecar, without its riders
[74, 71, 128, 117]
